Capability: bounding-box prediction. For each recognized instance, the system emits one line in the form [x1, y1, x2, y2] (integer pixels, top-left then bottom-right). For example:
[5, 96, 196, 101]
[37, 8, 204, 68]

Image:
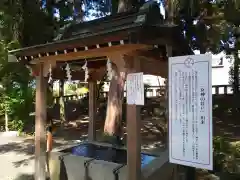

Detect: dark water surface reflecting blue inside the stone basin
[62, 143, 156, 167]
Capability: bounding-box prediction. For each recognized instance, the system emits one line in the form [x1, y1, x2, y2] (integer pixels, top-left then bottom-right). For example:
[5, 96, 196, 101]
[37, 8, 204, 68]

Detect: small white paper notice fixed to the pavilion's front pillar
[127, 73, 144, 105]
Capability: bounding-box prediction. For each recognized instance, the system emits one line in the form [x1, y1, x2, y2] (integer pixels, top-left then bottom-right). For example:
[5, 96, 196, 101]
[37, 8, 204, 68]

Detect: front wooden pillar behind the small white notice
[127, 58, 141, 180]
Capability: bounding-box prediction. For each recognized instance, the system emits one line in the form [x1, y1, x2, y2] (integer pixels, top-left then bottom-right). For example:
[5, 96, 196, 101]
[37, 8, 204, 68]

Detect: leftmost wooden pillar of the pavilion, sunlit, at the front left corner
[35, 64, 47, 180]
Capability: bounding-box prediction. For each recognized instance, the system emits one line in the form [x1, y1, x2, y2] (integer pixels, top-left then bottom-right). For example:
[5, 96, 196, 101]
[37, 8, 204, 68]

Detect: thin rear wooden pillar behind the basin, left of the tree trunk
[88, 81, 97, 141]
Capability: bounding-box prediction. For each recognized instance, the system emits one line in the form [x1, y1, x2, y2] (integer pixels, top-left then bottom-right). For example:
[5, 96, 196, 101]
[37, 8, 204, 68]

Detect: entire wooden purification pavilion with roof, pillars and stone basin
[9, 3, 190, 180]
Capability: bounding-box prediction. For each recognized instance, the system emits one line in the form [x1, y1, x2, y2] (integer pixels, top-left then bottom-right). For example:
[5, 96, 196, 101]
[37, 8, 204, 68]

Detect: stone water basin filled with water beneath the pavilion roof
[49, 142, 172, 180]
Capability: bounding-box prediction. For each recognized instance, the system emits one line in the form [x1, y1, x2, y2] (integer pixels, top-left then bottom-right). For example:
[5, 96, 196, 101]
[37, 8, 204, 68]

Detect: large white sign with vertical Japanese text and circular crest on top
[169, 55, 213, 170]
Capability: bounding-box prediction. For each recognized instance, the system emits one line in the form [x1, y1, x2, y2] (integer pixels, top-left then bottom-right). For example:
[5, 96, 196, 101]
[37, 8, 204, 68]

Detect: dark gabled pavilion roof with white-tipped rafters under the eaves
[10, 4, 190, 64]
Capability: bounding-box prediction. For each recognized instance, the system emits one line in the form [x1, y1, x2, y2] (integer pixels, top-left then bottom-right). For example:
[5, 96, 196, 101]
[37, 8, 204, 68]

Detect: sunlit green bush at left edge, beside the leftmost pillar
[0, 40, 34, 131]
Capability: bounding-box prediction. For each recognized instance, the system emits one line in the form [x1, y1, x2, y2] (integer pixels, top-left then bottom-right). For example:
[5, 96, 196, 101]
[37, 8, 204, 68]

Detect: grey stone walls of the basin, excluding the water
[49, 143, 175, 180]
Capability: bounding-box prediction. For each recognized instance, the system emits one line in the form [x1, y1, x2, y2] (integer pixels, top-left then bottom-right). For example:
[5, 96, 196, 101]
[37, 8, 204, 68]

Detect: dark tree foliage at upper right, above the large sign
[166, 0, 240, 97]
